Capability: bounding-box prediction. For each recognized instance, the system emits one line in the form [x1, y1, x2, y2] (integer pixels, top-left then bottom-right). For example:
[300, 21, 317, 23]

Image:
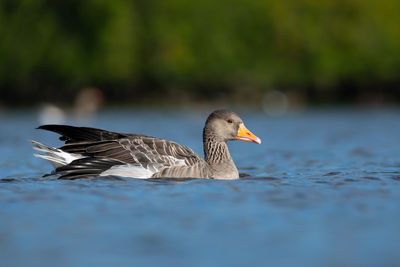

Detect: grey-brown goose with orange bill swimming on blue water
[31, 110, 261, 180]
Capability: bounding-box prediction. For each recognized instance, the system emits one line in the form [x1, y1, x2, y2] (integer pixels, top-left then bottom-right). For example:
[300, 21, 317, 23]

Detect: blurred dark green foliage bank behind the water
[0, 0, 400, 105]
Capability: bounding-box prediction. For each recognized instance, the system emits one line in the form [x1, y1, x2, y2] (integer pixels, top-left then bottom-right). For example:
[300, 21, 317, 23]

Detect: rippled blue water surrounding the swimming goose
[0, 109, 400, 266]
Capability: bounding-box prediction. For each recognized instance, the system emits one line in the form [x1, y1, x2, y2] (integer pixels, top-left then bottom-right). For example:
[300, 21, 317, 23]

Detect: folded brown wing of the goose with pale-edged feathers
[39, 125, 203, 178]
